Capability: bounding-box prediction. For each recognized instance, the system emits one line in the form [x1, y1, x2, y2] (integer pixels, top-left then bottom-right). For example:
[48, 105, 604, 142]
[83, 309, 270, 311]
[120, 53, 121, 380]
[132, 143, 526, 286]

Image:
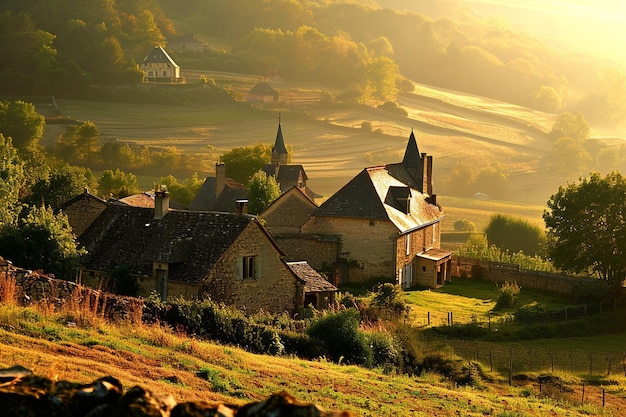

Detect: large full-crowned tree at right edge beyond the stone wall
[543, 172, 626, 283]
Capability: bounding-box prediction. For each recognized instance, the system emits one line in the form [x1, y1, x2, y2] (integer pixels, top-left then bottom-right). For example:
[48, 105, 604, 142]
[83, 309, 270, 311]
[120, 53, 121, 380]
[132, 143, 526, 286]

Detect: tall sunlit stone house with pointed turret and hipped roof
[302, 132, 452, 288]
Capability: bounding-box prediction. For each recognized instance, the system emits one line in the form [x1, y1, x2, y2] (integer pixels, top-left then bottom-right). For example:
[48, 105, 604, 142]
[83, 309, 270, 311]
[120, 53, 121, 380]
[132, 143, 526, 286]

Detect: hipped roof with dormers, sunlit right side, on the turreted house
[314, 164, 443, 233]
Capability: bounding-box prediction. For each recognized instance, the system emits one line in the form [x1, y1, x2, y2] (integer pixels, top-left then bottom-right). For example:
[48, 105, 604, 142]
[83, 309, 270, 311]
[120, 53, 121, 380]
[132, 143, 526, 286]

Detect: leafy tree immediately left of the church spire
[220, 143, 272, 184]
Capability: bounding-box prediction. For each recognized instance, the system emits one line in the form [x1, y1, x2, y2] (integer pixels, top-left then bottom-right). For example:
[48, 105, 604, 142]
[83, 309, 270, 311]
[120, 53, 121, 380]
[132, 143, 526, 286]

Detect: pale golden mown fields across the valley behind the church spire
[41, 71, 555, 213]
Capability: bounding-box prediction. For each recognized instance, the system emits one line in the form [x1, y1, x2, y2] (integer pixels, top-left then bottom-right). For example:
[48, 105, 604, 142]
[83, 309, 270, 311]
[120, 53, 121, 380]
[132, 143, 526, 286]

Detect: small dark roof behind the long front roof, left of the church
[189, 177, 250, 212]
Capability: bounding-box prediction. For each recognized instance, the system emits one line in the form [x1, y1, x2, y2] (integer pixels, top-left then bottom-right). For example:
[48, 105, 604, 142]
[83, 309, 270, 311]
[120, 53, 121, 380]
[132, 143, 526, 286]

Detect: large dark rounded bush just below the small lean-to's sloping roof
[307, 308, 372, 366]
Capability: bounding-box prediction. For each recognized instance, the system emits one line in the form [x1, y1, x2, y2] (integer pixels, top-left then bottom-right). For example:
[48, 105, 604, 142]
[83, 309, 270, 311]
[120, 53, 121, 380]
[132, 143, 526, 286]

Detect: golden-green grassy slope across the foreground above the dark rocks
[0, 296, 625, 416]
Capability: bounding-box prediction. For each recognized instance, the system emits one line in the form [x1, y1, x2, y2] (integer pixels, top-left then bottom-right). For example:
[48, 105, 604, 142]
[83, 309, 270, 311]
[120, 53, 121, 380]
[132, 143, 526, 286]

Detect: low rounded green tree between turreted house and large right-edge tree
[485, 214, 546, 255]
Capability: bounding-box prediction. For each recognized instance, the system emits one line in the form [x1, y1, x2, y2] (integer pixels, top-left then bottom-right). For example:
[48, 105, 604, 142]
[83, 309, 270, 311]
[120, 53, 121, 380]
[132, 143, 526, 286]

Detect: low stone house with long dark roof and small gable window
[78, 191, 334, 313]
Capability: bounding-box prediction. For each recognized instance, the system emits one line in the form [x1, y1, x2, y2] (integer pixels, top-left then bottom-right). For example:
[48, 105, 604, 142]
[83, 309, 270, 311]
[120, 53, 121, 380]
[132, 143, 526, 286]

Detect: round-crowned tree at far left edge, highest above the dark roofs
[0, 100, 46, 151]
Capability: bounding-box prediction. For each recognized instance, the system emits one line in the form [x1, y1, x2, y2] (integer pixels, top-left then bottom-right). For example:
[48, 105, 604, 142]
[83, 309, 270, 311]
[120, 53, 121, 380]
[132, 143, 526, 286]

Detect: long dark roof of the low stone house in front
[79, 204, 258, 283]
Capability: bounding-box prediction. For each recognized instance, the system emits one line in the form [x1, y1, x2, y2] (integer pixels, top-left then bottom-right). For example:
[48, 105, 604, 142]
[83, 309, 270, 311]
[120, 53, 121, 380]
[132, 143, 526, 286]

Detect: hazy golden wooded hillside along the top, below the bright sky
[0, 0, 626, 126]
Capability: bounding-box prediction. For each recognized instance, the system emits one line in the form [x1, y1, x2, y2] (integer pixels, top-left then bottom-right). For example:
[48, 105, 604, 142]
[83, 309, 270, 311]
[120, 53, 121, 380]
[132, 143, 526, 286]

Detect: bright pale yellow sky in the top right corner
[467, 0, 626, 62]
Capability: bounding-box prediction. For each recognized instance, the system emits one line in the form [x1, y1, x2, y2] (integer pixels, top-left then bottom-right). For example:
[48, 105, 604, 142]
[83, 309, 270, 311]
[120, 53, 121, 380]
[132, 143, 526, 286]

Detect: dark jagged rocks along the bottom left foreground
[0, 366, 352, 417]
